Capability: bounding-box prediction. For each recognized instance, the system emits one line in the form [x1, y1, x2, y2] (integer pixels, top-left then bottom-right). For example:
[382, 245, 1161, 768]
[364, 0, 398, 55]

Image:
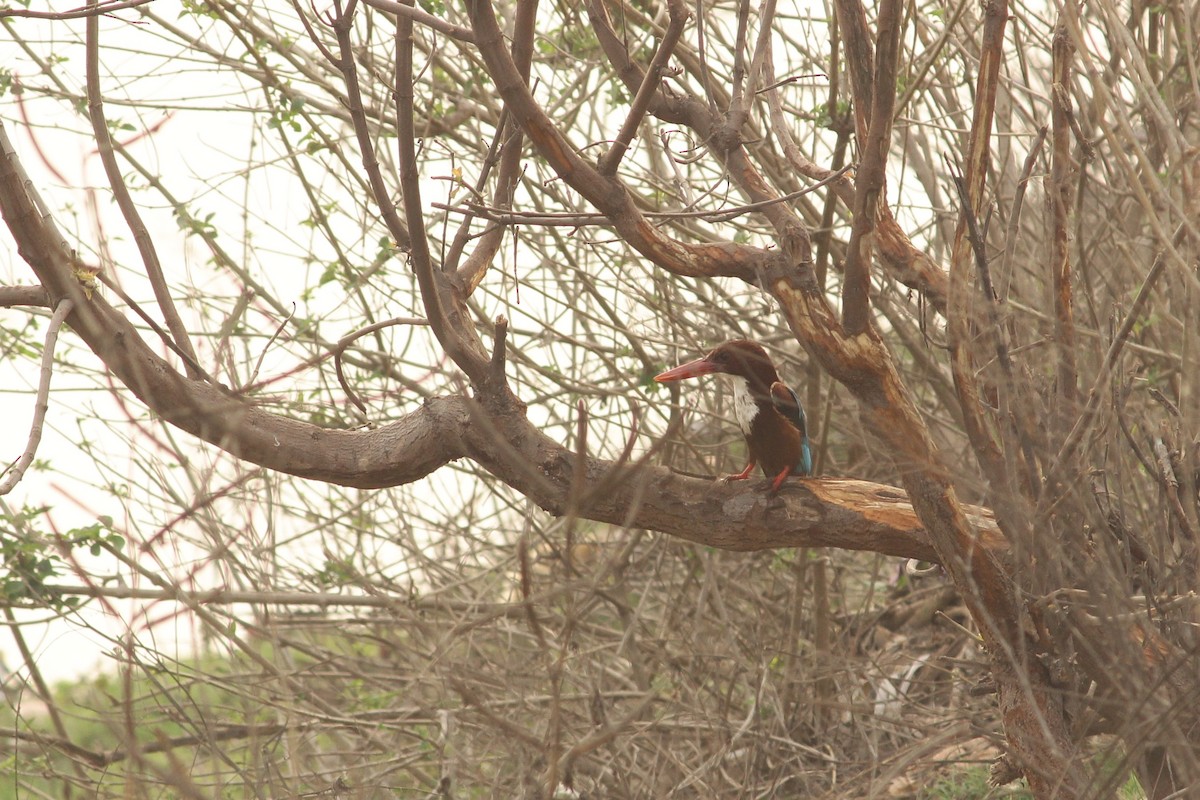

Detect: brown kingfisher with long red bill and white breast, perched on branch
[654, 339, 812, 494]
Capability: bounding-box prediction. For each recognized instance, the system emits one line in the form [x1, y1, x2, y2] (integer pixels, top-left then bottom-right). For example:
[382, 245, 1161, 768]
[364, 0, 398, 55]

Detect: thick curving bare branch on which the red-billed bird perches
[0, 115, 1002, 561]
